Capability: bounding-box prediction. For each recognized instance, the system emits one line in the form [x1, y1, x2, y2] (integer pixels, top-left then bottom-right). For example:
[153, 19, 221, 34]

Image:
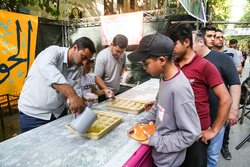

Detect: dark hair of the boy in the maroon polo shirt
[165, 23, 193, 48]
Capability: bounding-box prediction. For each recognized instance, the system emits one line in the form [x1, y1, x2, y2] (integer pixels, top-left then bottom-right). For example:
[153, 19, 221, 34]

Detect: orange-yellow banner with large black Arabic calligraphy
[0, 10, 38, 95]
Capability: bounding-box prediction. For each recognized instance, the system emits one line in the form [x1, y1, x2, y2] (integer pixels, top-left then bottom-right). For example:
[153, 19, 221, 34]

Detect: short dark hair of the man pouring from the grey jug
[70, 37, 96, 53]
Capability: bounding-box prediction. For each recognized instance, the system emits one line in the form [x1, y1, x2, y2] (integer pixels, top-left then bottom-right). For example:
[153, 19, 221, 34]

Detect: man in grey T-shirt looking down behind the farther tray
[95, 34, 128, 101]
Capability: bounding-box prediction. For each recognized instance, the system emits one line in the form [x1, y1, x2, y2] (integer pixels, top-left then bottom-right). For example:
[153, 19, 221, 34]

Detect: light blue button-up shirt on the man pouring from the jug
[18, 46, 82, 120]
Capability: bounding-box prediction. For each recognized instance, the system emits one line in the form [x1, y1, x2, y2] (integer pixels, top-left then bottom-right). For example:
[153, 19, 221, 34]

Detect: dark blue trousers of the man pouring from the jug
[19, 108, 67, 133]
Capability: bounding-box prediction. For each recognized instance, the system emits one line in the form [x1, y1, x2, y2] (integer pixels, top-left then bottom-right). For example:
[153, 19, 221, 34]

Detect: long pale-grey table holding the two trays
[0, 79, 159, 167]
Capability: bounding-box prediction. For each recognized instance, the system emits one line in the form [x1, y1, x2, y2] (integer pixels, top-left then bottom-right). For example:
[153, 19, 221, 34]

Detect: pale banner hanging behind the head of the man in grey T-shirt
[101, 12, 143, 45]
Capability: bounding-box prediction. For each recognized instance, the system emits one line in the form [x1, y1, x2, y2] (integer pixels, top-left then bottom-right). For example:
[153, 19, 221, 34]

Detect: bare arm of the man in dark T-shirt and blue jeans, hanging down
[227, 85, 241, 125]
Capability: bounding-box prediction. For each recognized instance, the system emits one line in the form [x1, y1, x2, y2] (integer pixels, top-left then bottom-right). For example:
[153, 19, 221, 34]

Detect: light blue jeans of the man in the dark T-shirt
[207, 126, 225, 167]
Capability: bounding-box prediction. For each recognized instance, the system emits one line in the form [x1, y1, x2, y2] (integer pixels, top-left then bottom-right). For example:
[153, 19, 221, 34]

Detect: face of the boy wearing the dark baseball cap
[143, 58, 163, 76]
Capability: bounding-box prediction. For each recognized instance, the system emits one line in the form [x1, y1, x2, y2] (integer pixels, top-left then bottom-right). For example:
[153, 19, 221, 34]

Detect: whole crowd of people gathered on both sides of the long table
[18, 24, 246, 167]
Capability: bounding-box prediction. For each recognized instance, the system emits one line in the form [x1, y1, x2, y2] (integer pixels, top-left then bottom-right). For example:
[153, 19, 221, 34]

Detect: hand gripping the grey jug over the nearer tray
[69, 95, 86, 114]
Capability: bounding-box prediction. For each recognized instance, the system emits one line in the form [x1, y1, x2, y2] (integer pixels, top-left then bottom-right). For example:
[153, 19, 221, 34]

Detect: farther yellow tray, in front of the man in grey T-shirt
[106, 98, 146, 114]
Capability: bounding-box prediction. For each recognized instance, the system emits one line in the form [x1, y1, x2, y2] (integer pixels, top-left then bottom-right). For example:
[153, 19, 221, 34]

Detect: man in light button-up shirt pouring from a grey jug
[18, 37, 96, 132]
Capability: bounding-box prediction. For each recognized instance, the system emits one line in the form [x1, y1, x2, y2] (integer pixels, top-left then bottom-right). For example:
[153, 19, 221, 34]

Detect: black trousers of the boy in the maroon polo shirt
[181, 140, 209, 167]
